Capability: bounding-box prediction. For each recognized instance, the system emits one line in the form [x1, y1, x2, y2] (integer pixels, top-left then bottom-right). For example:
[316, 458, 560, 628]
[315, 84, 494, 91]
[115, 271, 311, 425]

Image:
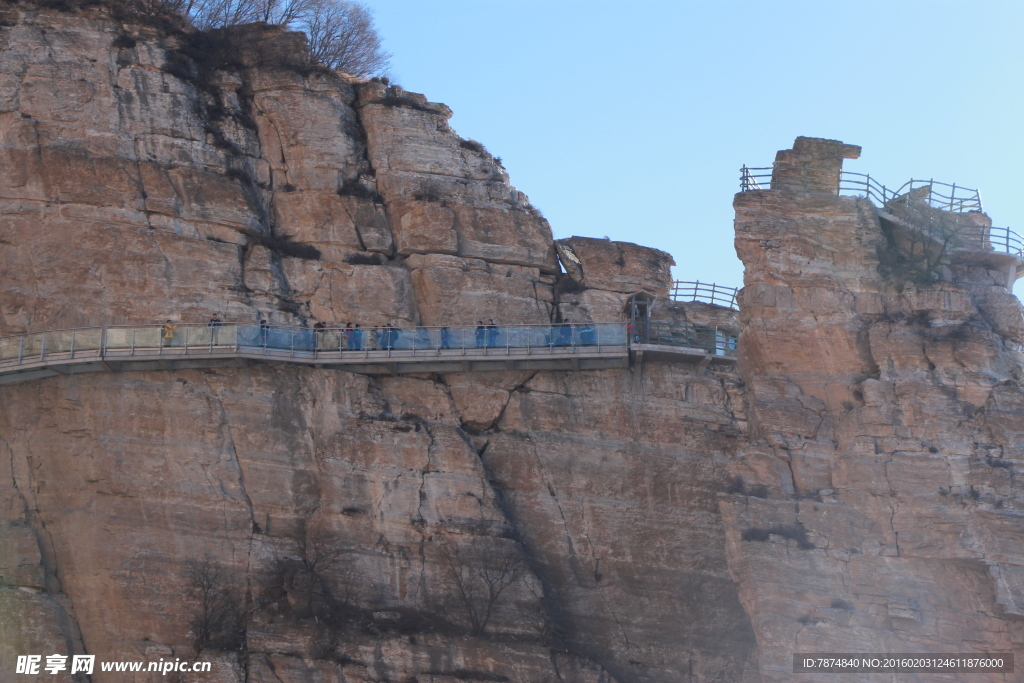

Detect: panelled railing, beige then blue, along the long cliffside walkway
[0, 323, 735, 385]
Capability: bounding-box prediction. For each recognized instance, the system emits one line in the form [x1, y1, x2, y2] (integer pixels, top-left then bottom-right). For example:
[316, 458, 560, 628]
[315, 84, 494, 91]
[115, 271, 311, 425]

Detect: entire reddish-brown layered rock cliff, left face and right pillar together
[0, 4, 1024, 683]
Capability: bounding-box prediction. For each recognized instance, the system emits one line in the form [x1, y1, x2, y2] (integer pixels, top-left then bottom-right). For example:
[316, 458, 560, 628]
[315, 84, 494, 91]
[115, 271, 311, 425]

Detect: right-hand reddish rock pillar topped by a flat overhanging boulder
[722, 140, 1024, 681]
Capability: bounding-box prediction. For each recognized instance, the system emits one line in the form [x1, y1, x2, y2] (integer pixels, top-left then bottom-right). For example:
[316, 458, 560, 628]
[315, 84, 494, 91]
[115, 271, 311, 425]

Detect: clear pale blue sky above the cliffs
[368, 0, 1024, 296]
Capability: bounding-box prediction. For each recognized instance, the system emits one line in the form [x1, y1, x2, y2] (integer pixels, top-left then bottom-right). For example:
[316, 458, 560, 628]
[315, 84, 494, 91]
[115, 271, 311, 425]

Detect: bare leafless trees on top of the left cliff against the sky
[182, 0, 391, 78]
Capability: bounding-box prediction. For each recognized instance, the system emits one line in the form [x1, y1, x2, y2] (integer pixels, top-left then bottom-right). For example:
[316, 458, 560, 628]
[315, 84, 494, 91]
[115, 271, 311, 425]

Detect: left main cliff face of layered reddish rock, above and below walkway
[0, 5, 760, 683]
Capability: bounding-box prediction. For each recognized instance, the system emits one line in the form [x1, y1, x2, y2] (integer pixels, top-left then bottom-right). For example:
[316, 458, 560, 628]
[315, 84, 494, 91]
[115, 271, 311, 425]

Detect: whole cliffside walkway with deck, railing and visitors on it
[0, 323, 735, 384]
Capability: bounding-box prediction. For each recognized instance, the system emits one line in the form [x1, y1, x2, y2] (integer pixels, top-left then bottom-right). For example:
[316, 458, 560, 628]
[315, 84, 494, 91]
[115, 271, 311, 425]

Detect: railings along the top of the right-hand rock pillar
[739, 166, 1024, 257]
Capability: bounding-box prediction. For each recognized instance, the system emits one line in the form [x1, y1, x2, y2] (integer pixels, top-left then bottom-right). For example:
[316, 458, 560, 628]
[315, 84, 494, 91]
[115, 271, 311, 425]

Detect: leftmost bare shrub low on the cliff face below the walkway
[184, 554, 245, 652]
